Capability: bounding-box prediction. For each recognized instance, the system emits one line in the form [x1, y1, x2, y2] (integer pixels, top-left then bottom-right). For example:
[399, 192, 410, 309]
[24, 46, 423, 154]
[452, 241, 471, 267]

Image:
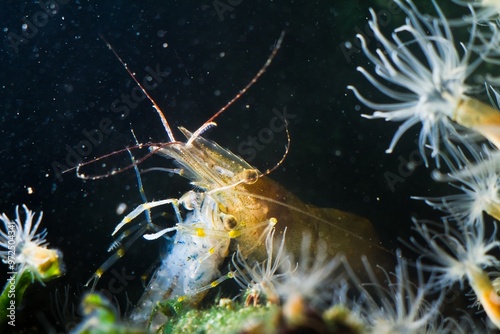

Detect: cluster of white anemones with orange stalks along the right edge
[349, 0, 500, 328]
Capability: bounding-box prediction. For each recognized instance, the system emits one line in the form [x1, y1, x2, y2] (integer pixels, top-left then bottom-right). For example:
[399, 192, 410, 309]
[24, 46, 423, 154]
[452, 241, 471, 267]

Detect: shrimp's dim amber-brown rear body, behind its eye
[237, 177, 393, 275]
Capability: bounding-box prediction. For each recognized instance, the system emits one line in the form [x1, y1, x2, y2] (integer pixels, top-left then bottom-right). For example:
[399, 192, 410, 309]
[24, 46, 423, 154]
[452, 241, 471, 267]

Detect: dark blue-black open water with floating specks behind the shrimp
[0, 0, 476, 332]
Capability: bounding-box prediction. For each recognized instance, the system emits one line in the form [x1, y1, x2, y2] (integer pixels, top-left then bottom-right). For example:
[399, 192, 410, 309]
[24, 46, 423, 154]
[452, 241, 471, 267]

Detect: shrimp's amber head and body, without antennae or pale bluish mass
[158, 128, 392, 278]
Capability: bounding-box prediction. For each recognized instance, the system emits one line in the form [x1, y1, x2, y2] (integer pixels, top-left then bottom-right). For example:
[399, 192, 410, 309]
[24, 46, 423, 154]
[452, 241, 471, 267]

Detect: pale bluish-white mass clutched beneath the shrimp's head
[130, 198, 229, 328]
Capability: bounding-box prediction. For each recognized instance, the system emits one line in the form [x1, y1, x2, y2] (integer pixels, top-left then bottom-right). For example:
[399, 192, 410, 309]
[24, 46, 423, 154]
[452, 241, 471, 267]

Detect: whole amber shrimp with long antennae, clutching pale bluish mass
[81, 34, 387, 330]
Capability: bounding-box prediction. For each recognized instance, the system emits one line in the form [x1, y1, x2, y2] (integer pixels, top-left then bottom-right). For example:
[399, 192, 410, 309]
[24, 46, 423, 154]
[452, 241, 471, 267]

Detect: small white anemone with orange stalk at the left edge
[0, 205, 62, 283]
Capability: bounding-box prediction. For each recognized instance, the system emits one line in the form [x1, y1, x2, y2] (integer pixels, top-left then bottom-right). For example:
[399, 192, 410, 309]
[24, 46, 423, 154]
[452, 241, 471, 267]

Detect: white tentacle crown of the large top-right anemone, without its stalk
[348, 0, 480, 166]
